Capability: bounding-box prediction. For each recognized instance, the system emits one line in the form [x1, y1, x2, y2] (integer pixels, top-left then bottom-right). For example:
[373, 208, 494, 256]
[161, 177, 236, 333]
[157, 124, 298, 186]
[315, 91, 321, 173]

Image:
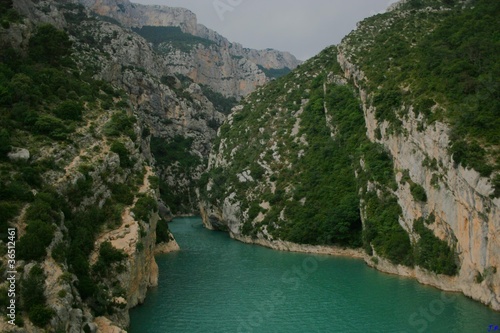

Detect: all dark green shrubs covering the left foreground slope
[0, 16, 154, 327]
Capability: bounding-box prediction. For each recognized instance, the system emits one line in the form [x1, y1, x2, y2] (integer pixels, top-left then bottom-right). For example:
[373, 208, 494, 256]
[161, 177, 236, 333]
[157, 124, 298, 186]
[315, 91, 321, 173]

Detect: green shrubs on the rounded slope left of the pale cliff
[200, 48, 412, 249]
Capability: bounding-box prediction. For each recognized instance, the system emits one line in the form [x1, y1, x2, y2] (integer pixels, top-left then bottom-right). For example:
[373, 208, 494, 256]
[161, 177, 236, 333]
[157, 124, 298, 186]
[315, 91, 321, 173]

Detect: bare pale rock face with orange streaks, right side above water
[338, 45, 500, 310]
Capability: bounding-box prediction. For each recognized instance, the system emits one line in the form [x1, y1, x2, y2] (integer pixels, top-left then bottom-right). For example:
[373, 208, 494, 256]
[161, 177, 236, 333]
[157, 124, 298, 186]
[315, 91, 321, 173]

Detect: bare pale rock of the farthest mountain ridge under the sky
[80, 0, 301, 98]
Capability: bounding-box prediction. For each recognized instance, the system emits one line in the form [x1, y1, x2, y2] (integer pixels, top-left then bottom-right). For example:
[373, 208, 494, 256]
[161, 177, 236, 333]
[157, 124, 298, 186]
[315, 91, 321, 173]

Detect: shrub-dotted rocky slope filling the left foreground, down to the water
[0, 1, 197, 332]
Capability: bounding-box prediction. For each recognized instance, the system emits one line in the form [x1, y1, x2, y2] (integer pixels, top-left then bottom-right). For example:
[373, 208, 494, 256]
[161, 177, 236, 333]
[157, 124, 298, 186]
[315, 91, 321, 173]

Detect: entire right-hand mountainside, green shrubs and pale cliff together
[201, 0, 500, 309]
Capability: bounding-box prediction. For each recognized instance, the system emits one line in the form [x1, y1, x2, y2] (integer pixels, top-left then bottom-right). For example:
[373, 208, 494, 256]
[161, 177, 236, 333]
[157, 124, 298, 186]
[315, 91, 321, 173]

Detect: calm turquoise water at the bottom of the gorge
[129, 218, 500, 333]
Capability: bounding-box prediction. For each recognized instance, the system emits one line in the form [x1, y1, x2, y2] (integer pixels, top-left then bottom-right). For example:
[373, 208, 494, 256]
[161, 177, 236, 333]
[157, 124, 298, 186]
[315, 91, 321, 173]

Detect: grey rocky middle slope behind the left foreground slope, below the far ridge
[50, 0, 225, 214]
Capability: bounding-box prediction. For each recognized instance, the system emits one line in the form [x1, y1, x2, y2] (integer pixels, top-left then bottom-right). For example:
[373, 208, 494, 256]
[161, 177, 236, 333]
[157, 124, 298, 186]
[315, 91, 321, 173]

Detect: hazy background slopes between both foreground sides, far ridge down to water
[69, 1, 297, 214]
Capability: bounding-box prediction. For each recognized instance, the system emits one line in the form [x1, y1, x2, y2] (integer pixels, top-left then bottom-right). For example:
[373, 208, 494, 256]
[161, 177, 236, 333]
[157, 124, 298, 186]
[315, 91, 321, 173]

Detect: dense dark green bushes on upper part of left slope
[0, 25, 121, 145]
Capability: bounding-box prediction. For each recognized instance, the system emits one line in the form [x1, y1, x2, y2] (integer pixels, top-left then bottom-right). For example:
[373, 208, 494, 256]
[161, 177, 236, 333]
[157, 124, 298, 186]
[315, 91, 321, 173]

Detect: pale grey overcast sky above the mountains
[131, 0, 395, 60]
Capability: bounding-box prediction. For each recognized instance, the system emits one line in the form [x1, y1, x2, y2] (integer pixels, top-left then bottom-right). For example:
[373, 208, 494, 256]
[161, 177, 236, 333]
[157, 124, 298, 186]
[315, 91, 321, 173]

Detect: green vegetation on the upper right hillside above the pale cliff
[345, 0, 500, 187]
